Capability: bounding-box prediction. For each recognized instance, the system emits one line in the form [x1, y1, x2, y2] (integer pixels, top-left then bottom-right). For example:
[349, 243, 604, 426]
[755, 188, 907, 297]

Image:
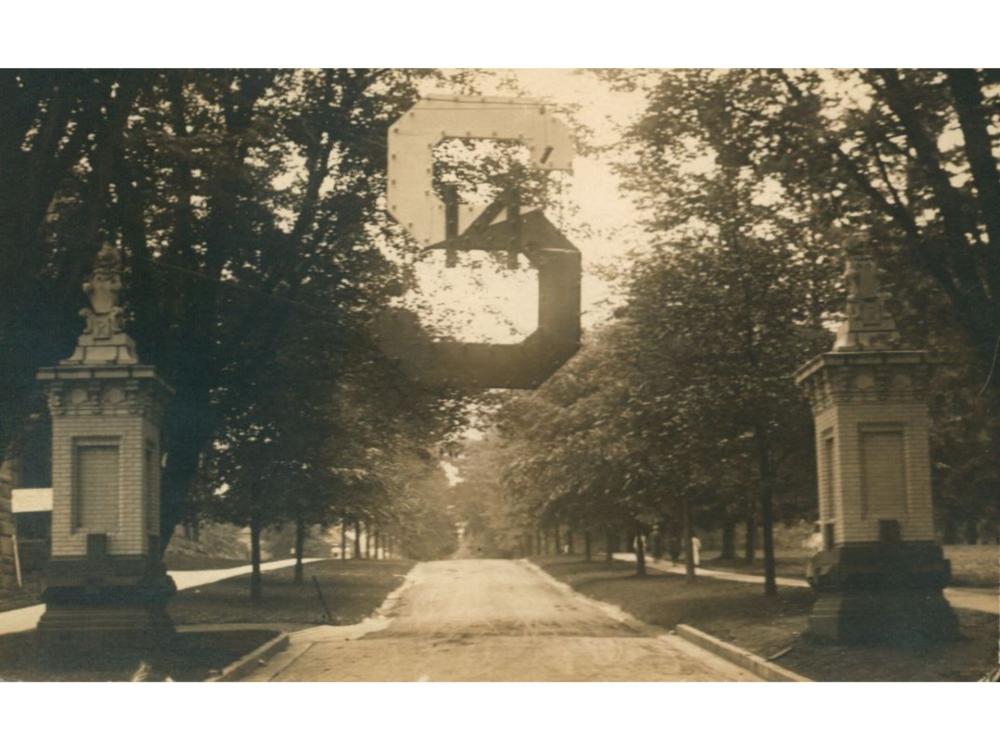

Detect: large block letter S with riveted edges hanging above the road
[379, 97, 580, 389]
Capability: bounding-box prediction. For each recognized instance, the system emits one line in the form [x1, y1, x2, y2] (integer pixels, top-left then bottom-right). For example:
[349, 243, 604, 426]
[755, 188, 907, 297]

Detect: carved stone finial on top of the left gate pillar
[63, 242, 139, 365]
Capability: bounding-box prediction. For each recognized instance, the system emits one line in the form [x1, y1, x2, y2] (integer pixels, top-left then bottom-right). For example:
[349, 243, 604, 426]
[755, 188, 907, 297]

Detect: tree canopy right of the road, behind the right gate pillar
[460, 70, 1000, 588]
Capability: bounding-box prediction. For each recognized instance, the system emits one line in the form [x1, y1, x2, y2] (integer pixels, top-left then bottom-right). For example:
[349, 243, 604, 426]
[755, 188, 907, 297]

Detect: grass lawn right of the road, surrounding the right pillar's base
[536, 557, 1000, 681]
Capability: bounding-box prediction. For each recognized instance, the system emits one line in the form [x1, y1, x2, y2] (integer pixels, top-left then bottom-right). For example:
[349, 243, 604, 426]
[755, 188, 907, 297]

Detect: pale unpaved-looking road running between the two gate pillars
[250, 560, 756, 681]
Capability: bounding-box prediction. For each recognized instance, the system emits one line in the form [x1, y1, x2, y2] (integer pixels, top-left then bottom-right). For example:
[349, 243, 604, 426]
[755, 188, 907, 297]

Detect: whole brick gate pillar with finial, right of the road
[795, 256, 957, 642]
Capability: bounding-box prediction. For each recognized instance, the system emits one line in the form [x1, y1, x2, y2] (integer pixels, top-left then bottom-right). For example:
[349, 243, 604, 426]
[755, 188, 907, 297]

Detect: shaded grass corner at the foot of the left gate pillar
[0, 629, 280, 682]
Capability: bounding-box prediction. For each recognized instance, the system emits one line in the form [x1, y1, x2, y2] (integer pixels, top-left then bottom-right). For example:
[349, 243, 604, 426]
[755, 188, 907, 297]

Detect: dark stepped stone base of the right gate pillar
[808, 542, 958, 643]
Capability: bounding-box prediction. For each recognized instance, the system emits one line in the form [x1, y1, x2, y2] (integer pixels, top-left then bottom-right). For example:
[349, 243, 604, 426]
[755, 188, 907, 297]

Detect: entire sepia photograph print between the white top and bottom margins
[0, 4, 1000, 745]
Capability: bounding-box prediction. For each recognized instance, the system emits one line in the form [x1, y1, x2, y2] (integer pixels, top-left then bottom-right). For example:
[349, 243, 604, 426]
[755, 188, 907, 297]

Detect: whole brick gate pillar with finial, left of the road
[38, 245, 175, 649]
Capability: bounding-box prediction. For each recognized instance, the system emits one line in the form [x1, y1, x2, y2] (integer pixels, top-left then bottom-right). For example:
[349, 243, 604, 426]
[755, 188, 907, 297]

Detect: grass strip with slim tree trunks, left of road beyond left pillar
[169, 560, 413, 627]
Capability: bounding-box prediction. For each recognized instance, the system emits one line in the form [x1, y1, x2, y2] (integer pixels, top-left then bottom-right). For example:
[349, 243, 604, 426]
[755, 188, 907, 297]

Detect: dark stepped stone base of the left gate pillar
[37, 558, 176, 653]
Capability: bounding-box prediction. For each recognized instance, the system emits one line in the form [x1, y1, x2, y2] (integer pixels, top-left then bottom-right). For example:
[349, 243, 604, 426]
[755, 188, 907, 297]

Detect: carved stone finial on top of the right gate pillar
[833, 250, 899, 351]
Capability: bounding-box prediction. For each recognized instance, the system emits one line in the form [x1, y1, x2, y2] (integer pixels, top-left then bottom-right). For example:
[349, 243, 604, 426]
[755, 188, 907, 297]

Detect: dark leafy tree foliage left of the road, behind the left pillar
[0, 69, 470, 564]
